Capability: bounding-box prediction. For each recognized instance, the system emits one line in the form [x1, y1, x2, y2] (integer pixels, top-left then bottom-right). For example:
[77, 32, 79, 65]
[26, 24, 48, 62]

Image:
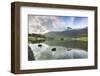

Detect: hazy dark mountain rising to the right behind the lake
[45, 27, 88, 37]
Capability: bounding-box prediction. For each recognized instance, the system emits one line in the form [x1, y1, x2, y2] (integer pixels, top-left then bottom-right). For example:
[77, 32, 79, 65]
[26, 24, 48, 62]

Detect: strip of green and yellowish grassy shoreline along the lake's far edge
[28, 36, 88, 43]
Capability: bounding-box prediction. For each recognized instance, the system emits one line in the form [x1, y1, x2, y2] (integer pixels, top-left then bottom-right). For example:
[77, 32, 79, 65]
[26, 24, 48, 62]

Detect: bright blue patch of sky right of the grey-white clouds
[59, 16, 88, 28]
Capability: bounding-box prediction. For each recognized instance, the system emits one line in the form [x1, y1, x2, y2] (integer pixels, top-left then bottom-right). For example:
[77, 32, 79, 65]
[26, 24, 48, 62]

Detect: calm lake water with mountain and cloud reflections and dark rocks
[29, 40, 88, 60]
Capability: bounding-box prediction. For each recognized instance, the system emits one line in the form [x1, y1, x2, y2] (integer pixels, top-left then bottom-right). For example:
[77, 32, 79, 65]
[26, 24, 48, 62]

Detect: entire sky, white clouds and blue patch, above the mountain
[28, 15, 88, 34]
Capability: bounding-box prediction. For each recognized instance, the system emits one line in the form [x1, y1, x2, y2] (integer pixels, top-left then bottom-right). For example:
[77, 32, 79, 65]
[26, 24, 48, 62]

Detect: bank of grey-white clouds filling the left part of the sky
[28, 15, 66, 34]
